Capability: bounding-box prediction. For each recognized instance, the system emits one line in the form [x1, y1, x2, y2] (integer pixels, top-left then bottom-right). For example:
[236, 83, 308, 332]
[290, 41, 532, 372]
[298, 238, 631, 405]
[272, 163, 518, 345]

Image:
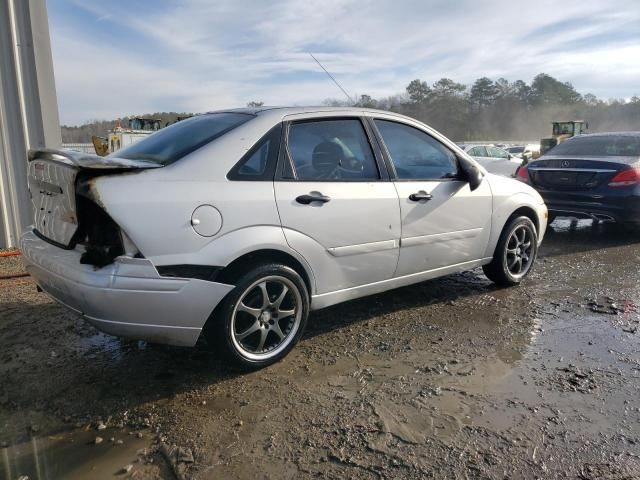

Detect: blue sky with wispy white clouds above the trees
[47, 0, 640, 125]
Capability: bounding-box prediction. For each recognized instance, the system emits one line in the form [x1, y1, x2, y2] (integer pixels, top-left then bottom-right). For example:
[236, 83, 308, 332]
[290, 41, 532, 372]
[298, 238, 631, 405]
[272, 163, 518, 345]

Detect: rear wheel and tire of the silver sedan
[205, 263, 309, 369]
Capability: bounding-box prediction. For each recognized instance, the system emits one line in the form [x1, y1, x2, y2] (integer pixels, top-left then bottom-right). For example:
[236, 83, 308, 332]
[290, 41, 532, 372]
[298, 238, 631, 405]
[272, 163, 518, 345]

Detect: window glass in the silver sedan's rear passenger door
[287, 118, 380, 181]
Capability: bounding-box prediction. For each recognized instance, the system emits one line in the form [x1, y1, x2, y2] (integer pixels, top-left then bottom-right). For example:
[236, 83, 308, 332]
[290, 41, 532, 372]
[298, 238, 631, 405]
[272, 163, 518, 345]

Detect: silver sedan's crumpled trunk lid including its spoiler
[28, 149, 162, 248]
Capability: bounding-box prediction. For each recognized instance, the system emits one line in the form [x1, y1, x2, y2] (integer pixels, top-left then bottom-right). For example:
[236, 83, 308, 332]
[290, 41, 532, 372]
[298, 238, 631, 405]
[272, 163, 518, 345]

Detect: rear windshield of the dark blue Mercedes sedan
[548, 135, 640, 157]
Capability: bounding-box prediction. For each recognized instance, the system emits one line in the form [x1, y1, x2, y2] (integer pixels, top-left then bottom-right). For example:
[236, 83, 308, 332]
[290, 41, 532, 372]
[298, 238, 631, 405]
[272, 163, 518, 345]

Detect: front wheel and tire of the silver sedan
[482, 216, 538, 286]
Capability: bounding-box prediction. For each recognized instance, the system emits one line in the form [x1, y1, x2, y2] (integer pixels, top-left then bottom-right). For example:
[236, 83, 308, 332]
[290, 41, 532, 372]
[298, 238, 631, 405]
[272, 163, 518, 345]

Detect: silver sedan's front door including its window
[373, 118, 492, 276]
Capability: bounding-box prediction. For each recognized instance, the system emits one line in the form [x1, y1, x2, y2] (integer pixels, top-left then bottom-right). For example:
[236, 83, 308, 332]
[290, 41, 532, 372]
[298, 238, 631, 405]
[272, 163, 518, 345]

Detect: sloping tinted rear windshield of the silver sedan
[110, 113, 254, 165]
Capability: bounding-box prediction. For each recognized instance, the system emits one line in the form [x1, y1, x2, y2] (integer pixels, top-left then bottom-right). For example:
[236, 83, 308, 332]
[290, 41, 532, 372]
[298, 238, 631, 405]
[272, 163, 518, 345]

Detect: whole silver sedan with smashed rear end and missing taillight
[21, 107, 547, 367]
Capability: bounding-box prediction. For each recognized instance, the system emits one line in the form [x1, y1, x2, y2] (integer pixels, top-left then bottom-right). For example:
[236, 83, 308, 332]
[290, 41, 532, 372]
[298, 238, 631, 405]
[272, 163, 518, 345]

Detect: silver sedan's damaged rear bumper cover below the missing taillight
[20, 229, 233, 346]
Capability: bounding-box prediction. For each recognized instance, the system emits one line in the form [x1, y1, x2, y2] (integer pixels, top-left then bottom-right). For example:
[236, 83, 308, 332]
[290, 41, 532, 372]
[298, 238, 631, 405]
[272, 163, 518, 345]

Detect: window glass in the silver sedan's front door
[375, 119, 458, 180]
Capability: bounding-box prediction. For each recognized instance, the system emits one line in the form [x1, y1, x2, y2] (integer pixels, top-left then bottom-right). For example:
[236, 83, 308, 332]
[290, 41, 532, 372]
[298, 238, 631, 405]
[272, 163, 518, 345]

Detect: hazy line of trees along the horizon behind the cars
[62, 73, 640, 143]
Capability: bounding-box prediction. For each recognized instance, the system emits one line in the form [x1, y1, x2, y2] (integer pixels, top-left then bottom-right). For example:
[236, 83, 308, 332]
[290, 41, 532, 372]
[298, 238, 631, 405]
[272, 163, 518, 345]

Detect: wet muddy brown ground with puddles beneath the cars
[0, 220, 640, 480]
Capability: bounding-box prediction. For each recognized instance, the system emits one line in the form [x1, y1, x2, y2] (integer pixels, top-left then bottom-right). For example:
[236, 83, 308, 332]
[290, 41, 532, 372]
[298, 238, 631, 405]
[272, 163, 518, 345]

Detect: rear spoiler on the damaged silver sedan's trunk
[28, 148, 164, 170]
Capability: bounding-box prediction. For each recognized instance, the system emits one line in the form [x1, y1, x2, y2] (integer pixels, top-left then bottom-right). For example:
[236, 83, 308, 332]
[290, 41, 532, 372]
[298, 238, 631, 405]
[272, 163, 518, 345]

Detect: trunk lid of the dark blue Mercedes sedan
[527, 156, 637, 192]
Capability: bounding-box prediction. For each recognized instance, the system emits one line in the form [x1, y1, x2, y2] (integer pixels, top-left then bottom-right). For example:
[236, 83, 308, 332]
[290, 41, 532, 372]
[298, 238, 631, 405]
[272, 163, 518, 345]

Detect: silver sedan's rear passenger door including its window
[275, 116, 400, 293]
